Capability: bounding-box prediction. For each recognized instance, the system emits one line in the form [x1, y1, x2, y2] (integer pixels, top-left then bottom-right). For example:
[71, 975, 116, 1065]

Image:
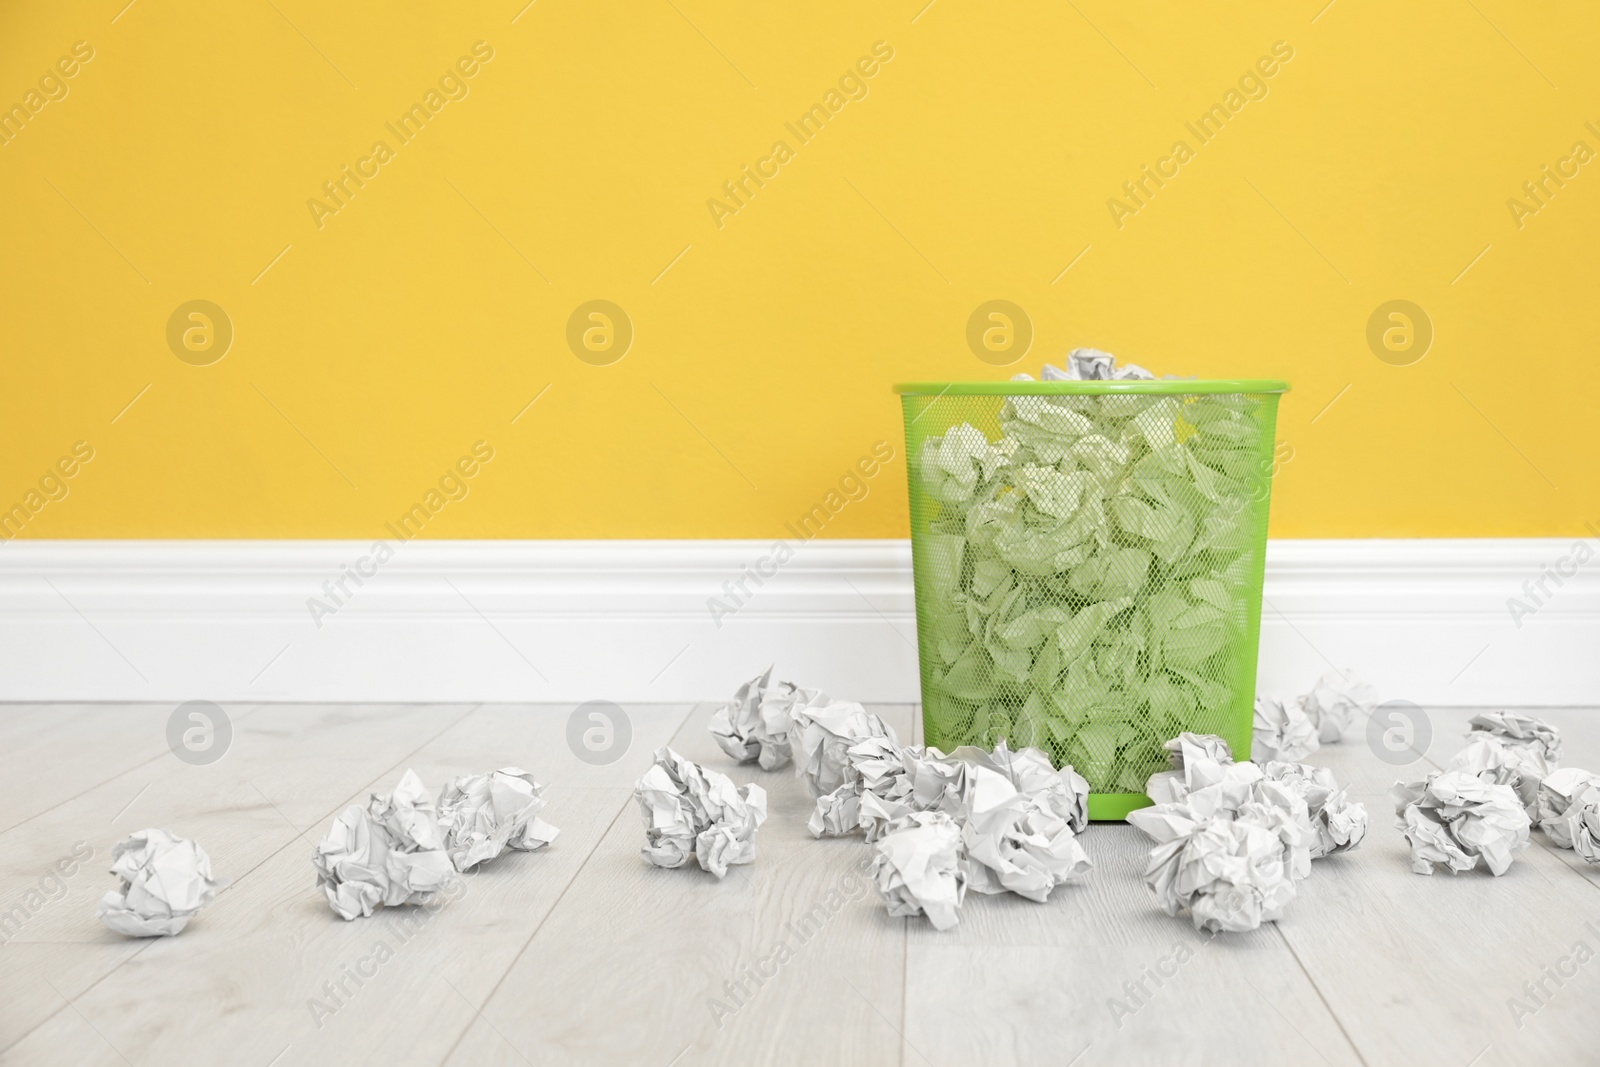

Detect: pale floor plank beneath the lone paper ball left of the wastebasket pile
[448, 707, 915, 1067]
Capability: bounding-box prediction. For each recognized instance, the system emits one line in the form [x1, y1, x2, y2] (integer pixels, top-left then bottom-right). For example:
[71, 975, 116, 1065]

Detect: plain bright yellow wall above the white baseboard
[0, 0, 1600, 537]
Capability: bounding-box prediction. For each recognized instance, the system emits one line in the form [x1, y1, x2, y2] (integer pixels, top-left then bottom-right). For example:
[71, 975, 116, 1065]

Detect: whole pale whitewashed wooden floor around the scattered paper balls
[0, 705, 1600, 1067]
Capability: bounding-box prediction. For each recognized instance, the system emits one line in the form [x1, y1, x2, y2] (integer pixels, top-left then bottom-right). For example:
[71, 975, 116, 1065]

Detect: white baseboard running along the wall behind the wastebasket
[0, 539, 1600, 707]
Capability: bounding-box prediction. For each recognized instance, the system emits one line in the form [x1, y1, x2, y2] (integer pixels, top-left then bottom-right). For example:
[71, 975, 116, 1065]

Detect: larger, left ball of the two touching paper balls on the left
[312, 769, 456, 920]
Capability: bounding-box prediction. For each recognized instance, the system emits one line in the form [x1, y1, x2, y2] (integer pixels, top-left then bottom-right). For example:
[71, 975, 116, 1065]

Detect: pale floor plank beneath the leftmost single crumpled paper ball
[0, 705, 483, 1051]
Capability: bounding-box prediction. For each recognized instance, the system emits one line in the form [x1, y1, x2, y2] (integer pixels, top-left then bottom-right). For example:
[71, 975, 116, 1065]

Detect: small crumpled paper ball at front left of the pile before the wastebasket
[872, 811, 966, 929]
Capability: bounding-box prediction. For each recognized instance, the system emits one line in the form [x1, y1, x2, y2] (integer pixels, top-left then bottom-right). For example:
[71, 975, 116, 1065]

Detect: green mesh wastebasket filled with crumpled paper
[894, 381, 1288, 819]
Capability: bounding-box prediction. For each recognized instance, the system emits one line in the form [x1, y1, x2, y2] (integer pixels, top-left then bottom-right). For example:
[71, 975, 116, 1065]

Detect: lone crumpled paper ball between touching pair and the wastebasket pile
[634, 747, 766, 878]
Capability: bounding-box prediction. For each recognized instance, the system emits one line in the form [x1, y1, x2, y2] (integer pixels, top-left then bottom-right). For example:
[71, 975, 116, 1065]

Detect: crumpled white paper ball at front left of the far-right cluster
[1389, 771, 1530, 877]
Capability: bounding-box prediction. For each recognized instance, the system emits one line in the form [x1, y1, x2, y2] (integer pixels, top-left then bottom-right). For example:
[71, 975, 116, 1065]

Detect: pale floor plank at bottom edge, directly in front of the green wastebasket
[904, 824, 1358, 1067]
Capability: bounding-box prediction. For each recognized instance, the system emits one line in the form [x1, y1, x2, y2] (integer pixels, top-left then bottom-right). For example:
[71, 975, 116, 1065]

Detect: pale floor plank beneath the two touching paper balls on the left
[0, 707, 683, 1065]
